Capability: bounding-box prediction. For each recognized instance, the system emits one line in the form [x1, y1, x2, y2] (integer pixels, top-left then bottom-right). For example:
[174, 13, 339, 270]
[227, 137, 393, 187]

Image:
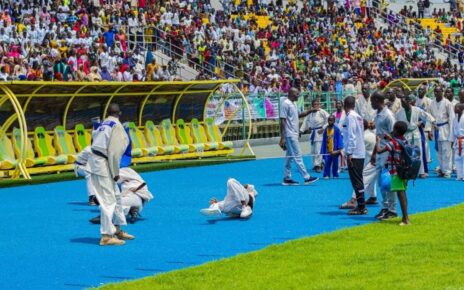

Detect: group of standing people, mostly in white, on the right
[280, 84, 464, 225]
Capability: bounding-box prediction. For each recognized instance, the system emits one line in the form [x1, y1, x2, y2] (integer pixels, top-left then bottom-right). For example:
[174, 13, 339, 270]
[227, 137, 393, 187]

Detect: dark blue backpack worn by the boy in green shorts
[395, 139, 422, 180]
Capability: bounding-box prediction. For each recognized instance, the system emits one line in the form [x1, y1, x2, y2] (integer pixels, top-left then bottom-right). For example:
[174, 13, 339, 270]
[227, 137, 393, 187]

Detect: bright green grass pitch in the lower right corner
[99, 204, 464, 290]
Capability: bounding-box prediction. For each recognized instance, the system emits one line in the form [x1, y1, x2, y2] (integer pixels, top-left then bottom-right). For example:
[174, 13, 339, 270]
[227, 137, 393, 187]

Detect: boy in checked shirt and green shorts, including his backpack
[374, 121, 420, 226]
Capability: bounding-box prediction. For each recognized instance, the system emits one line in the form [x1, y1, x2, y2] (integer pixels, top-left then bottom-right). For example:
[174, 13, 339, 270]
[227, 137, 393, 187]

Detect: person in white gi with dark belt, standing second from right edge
[429, 85, 454, 178]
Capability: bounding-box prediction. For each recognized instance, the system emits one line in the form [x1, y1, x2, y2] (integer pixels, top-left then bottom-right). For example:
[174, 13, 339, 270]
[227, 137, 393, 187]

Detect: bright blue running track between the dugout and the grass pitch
[0, 158, 464, 289]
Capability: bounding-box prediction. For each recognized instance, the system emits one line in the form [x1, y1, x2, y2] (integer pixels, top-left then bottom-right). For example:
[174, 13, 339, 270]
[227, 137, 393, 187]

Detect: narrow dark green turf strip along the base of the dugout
[0, 155, 256, 188]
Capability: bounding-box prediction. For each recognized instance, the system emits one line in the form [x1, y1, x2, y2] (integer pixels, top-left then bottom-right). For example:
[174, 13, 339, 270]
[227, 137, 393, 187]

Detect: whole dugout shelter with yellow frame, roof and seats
[0, 79, 253, 179]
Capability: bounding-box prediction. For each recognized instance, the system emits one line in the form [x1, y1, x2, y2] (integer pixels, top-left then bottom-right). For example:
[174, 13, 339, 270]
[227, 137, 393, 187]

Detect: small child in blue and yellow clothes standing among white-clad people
[321, 115, 343, 179]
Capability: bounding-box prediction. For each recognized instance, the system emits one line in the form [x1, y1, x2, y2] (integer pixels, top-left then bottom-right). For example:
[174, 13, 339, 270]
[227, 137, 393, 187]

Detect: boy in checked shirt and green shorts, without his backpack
[374, 121, 409, 226]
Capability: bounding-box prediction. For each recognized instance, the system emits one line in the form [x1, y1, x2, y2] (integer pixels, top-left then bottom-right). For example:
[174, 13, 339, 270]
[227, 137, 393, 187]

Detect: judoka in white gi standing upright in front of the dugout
[88, 104, 134, 246]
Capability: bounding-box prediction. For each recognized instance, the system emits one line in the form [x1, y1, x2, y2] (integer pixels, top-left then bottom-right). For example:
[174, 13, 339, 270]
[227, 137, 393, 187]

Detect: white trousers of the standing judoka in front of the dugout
[90, 174, 127, 235]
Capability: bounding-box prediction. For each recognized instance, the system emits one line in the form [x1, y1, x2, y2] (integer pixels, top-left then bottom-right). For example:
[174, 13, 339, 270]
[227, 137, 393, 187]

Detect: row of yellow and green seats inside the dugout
[0, 119, 233, 176]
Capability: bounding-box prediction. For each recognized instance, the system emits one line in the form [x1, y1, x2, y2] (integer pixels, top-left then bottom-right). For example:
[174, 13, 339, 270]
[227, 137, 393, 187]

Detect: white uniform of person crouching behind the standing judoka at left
[118, 167, 153, 215]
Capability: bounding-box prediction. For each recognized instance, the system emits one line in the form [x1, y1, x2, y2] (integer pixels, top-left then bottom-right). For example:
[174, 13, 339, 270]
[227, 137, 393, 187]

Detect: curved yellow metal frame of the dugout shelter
[0, 79, 253, 179]
